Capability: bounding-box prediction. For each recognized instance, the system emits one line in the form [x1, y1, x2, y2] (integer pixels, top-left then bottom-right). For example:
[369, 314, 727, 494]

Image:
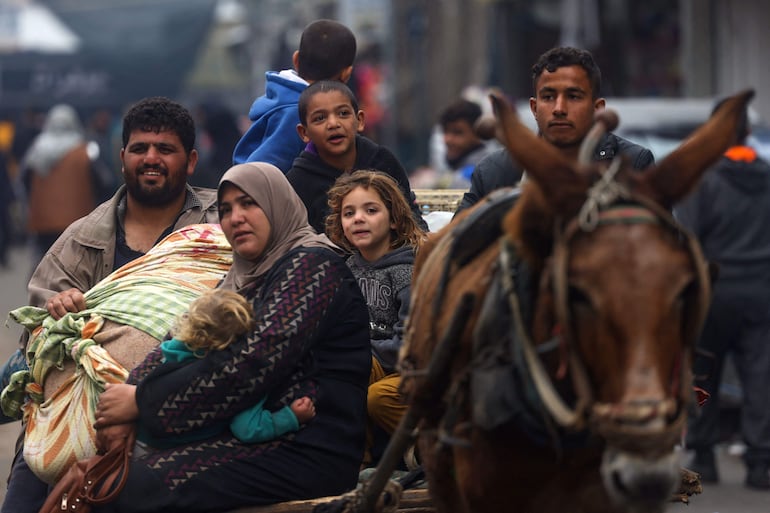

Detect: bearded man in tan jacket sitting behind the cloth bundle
[0, 97, 219, 513]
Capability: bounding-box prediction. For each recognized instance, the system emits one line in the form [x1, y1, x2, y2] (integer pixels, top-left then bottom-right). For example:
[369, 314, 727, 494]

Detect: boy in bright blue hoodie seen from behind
[233, 20, 356, 173]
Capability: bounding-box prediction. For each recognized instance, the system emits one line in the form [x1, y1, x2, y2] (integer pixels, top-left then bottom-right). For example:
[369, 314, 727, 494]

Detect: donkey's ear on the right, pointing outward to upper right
[639, 89, 754, 208]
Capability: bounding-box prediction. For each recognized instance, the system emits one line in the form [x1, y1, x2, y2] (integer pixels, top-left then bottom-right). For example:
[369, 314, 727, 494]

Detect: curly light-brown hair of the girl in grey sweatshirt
[326, 170, 425, 252]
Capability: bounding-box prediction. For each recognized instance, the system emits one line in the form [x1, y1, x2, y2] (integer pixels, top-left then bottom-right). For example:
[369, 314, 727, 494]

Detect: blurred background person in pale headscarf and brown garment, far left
[21, 104, 96, 268]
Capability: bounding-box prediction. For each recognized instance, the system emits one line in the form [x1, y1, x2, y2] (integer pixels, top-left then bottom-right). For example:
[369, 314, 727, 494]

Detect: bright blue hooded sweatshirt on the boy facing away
[233, 70, 307, 173]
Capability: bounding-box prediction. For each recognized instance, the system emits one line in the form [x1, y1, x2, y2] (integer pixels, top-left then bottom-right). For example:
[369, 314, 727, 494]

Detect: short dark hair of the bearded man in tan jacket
[123, 96, 195, 154]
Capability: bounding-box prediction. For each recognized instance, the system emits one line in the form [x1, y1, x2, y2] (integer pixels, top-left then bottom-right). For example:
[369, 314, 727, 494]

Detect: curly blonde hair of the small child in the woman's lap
[174, 289, 254, 352]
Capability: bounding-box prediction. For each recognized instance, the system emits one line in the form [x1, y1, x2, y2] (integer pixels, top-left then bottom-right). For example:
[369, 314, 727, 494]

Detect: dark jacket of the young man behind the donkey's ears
[455, 133, 655, 214]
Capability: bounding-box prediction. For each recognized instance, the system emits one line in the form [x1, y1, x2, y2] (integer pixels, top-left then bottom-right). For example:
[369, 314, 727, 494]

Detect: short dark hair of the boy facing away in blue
[297, 20, 356, 82]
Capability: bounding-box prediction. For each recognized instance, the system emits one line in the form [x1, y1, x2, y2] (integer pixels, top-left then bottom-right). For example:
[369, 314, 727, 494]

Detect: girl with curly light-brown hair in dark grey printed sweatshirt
[326, 170, 426, 465]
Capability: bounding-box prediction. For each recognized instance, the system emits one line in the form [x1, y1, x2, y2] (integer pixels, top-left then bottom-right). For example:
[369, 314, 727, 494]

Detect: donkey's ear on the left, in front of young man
[489, 92, 588, 215]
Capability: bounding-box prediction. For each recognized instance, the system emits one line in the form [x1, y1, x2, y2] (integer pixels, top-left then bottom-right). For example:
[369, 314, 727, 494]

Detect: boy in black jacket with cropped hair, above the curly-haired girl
[286, 80, 427, 233]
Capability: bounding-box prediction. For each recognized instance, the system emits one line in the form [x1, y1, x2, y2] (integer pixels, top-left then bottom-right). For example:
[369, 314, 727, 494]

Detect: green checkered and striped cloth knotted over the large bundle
[0, 224, 232, 417]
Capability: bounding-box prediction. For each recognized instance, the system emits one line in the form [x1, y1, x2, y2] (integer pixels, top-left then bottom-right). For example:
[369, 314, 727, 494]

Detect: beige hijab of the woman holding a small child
[218, 162, 339, 290]
